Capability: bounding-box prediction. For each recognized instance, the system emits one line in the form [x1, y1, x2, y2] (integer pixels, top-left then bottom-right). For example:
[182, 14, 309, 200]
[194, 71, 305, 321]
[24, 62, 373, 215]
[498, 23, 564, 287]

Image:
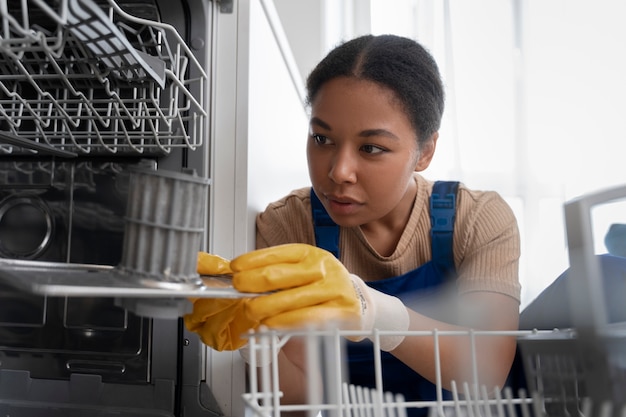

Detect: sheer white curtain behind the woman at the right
[371, 0, 626, 307]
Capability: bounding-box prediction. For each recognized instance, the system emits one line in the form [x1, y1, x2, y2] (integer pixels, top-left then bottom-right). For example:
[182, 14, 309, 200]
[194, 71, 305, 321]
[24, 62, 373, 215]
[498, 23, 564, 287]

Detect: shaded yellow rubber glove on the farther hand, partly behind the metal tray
[184, 252, 259, 351]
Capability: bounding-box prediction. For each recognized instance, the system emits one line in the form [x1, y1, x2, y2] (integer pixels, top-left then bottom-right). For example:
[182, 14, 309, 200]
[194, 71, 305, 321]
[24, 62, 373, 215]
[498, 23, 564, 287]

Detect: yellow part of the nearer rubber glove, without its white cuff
[231, 244, 361, 329]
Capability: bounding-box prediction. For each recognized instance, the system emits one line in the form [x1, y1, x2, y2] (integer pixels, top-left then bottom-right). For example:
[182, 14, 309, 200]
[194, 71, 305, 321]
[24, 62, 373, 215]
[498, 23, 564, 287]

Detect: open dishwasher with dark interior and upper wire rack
[0, 0, 222, 417]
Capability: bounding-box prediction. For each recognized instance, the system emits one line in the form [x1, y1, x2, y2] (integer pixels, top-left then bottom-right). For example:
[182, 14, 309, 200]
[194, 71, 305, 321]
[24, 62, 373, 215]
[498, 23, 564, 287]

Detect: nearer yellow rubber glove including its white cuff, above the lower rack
[230, 243, 409, 351]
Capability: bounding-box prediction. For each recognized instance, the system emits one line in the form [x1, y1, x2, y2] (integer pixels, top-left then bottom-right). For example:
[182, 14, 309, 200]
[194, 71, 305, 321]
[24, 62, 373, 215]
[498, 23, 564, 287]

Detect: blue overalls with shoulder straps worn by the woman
[311, 181, 458, 416]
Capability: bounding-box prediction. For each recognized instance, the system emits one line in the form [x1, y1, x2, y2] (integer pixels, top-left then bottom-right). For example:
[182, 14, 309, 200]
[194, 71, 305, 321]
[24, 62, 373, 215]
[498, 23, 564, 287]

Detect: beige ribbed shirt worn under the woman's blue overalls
[256, 174, 520, 302]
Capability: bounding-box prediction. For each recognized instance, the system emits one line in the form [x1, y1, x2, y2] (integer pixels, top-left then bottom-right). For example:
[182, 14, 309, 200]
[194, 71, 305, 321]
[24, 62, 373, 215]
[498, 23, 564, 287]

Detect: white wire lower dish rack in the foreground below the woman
[243, 329, 626, 417]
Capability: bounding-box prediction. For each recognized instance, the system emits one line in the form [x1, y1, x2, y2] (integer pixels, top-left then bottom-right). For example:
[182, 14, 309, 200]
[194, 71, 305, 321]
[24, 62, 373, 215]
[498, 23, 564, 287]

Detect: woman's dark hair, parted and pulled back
[306, 35, 445, 142]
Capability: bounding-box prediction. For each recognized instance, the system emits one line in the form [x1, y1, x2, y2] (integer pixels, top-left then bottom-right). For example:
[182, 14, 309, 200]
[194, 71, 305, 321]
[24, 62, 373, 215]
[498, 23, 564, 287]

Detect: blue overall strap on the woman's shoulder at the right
[430, 181, 459, 276]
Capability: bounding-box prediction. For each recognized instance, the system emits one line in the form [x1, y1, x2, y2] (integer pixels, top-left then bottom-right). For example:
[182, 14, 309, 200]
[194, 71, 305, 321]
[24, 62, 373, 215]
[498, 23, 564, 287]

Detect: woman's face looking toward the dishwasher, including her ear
[307, 77, 436, 227]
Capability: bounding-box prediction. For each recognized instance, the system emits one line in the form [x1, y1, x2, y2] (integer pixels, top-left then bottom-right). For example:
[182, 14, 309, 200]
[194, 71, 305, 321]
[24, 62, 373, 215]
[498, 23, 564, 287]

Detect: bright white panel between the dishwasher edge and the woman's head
[247, 1, 310, 249]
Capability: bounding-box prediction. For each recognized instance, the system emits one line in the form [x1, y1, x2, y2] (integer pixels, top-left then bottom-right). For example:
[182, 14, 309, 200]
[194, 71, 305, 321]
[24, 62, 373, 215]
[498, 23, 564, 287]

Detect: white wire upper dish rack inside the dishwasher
[0, 0, 207, 155]
